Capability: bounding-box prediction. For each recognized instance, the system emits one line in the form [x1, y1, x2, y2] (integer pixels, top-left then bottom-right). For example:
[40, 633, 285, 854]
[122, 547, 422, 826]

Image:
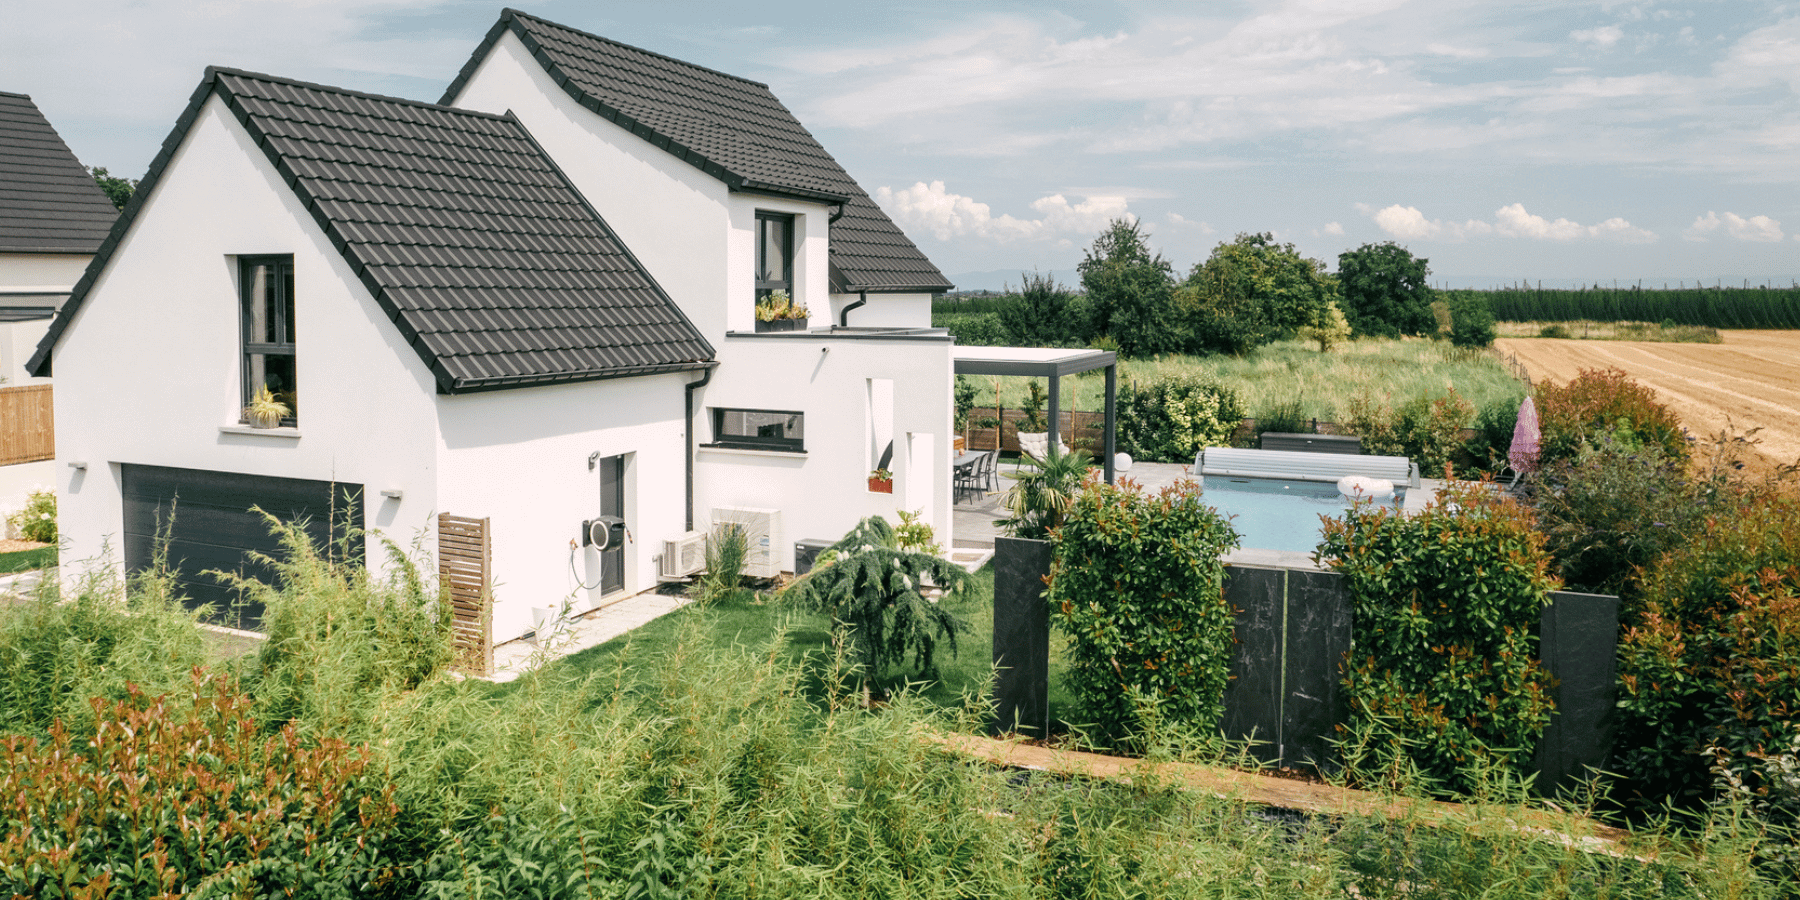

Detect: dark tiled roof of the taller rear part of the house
[443, 9, 952, 292]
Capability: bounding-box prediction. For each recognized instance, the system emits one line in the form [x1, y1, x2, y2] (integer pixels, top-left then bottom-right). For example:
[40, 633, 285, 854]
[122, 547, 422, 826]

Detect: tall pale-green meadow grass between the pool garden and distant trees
[970, 338, 1525, 421]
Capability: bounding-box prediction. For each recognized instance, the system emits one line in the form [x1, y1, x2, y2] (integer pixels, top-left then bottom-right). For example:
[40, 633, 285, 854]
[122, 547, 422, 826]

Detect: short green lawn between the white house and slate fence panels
[553, 565, 1073, 722]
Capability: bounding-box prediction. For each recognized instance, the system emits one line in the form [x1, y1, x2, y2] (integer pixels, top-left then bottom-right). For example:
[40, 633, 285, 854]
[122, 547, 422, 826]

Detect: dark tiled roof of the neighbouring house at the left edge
[0, 90, 119, 254]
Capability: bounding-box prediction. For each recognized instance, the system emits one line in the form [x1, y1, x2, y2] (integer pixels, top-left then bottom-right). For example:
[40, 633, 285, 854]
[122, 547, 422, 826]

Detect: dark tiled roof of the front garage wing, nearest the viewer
[31, 68, 713, 394]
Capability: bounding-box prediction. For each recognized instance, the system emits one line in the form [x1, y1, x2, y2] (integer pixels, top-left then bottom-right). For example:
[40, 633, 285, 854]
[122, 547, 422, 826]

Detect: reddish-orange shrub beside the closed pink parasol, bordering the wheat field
[1537, 369, 1688, 466]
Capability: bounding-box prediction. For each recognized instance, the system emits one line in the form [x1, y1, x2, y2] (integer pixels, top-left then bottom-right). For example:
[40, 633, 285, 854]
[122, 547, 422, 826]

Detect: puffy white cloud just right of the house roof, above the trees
[875, 182, 1130, 243]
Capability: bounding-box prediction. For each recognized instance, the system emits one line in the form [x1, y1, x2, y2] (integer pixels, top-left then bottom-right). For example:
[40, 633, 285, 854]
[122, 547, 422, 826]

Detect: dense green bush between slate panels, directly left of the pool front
[1048, 481, 1238, 742]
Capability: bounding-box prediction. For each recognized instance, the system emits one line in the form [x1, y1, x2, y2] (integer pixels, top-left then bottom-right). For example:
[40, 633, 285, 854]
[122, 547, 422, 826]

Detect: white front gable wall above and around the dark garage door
[52, 99, 437, 576]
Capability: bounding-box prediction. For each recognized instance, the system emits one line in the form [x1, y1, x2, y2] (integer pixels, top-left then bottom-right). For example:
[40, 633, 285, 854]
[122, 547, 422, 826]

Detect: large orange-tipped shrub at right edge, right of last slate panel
[1613, 495, 1800, 808]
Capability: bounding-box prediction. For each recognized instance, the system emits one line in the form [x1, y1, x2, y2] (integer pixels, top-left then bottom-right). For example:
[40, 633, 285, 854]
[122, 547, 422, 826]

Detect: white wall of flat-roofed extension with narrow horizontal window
[695, 335, 952, 571]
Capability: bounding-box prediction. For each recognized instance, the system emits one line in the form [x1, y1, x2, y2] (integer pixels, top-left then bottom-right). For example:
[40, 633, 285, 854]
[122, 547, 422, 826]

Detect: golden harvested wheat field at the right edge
[1494, 331, 1800, 468]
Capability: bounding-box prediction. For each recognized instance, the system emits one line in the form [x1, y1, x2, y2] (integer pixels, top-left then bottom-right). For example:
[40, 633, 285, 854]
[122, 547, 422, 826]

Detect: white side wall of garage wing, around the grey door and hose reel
[437, 373, 698, 641]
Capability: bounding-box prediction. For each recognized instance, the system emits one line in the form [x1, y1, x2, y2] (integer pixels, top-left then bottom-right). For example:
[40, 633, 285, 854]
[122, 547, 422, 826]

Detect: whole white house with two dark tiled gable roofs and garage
[31, 13, 952, 662]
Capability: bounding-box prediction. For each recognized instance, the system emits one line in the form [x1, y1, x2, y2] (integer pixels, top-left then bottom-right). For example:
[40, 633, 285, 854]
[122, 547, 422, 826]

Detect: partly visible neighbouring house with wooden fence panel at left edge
[0, 90, 119, 515]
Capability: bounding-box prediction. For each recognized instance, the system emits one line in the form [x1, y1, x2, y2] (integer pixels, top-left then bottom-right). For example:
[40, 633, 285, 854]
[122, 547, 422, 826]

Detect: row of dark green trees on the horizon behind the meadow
[936, 218, 1492, 356]
